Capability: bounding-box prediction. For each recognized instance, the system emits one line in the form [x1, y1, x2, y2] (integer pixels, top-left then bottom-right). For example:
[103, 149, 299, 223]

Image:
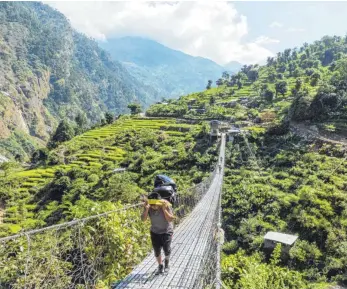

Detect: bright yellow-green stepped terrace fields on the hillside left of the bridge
[10, 119, 193, 196]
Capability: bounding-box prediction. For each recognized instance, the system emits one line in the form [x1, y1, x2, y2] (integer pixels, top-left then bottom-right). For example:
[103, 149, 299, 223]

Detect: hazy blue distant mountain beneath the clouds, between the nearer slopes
[100, 37, 227, 98]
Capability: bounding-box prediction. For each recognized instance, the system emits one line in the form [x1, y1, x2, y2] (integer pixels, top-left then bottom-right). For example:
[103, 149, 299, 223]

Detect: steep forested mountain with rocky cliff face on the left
[0, 2, 159, 158]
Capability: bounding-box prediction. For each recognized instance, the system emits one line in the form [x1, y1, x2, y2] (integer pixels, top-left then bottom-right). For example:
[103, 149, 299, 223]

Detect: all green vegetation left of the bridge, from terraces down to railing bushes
[0, 116, 217, 288]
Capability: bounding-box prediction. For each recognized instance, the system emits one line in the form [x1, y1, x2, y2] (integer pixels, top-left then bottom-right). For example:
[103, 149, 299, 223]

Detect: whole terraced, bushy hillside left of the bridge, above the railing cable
[0, 117, 216, 235]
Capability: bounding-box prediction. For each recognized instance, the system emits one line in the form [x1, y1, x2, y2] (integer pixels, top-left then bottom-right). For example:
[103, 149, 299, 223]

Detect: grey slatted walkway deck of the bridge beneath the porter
[113, 134, 225, 289]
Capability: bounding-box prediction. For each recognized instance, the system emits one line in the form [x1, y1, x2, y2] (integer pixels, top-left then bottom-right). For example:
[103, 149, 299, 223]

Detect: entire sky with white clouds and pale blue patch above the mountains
[46, 0, 347, 65]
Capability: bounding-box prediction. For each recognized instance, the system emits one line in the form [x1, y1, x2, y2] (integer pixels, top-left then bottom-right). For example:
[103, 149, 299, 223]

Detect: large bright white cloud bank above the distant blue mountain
[47, 1, 274, 64]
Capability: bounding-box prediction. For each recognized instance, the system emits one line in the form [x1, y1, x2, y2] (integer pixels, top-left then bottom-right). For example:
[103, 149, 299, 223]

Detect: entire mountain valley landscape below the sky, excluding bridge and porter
[0, 2, 347, 289]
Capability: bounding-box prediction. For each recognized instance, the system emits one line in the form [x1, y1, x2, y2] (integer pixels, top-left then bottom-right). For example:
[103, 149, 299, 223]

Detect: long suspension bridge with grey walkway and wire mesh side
[0, 134, 225, 289]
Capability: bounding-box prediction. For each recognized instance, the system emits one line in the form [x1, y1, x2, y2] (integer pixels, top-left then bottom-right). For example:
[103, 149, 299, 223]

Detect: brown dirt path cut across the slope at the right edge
[290, 122, 347, 146]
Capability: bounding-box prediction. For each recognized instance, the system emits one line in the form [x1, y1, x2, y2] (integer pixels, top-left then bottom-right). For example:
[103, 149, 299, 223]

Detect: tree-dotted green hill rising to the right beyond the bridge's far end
[148, 36, 347, 133]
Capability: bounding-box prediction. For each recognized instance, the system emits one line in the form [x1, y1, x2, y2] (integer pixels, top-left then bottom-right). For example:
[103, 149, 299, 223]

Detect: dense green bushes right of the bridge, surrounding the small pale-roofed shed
[222, 130, 347, 288]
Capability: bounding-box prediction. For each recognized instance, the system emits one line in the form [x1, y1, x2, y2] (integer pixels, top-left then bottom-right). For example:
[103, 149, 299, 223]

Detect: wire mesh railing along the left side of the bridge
[0, 169, 216, 289]
